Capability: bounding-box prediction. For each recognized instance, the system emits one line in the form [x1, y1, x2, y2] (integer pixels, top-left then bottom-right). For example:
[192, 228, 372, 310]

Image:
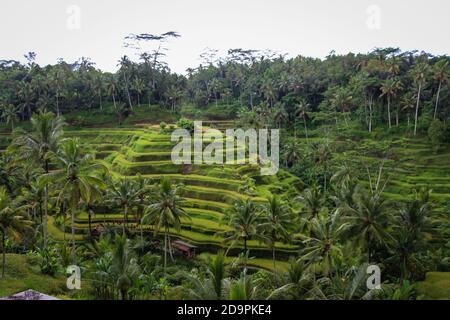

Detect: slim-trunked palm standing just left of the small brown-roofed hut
[142, 177, 189, 272]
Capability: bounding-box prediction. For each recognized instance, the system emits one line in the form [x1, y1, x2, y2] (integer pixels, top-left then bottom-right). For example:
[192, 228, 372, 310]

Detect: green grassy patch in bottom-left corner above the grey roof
[0, 254, 67, 297]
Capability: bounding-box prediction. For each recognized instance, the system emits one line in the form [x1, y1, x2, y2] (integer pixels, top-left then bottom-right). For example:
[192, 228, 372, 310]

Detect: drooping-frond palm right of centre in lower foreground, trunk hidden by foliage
[300, 213, 348, 275]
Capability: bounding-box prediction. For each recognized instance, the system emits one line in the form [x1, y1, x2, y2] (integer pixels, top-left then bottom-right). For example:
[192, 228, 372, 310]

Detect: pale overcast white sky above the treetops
[0, 0, 450, 72]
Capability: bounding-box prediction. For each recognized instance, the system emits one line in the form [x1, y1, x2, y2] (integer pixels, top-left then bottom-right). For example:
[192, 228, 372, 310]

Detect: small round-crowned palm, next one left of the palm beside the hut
[106, 179, 144, 234]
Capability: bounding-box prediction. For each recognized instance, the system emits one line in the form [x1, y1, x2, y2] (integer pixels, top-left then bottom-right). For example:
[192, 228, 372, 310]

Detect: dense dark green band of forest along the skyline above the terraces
[0, 48, 450, 133]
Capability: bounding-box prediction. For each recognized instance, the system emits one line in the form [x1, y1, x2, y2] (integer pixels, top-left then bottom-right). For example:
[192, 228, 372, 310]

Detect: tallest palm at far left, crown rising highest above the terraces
[14, 112, 64, 247]
